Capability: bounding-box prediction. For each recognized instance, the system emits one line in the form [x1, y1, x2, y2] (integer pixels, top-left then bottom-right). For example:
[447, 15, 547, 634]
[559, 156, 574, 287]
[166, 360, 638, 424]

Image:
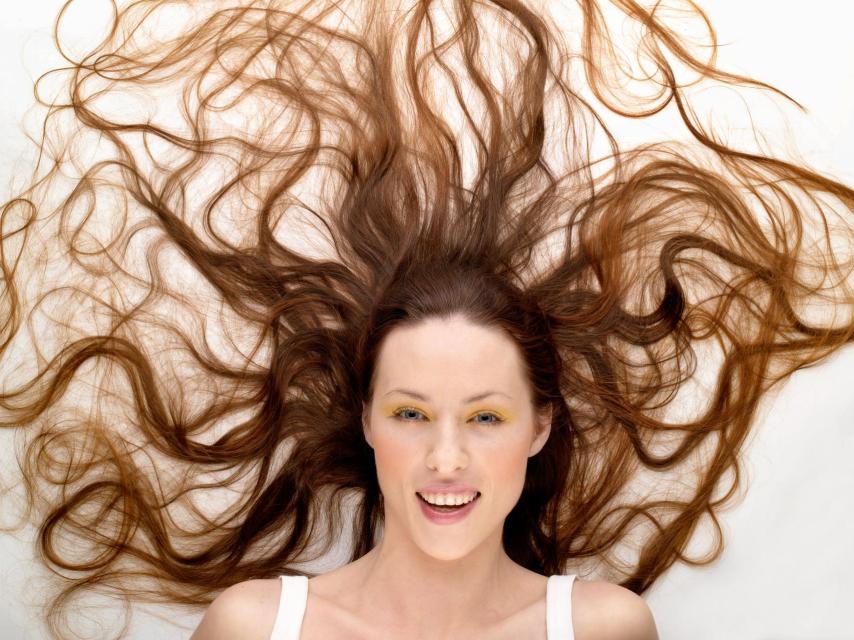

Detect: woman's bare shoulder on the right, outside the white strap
[572, 579, 658, 640]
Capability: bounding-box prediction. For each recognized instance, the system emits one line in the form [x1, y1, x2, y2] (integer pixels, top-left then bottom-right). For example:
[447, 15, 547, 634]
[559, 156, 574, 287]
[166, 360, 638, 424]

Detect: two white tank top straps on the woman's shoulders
[270, 575, 575, 640]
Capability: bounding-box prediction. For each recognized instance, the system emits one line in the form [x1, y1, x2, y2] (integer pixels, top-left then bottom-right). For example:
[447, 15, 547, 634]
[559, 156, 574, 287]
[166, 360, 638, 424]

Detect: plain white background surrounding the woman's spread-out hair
[0, 0, 854, 640]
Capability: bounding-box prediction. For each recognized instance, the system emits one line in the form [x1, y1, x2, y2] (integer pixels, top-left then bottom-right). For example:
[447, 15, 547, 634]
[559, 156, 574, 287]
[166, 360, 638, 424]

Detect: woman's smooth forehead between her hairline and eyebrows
[375, 316, 526, 399]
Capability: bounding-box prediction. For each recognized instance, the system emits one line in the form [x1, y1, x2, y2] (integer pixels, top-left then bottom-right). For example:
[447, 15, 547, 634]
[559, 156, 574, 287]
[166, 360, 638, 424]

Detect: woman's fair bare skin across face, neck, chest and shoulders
[193, 316, 658, 640]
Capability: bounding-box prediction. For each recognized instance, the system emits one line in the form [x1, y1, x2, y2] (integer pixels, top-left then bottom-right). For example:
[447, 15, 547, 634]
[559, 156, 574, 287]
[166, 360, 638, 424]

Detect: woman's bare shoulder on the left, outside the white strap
[190, 578, 281, 640]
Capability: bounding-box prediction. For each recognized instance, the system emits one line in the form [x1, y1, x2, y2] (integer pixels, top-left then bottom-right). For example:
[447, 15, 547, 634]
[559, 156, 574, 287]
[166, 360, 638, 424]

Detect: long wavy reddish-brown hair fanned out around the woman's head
[0, 0, 854, 637]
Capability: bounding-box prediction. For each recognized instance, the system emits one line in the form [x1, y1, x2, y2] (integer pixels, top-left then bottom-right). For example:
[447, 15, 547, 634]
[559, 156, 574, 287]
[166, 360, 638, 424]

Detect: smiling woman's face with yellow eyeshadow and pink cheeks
[363, 316, 551, 560]
